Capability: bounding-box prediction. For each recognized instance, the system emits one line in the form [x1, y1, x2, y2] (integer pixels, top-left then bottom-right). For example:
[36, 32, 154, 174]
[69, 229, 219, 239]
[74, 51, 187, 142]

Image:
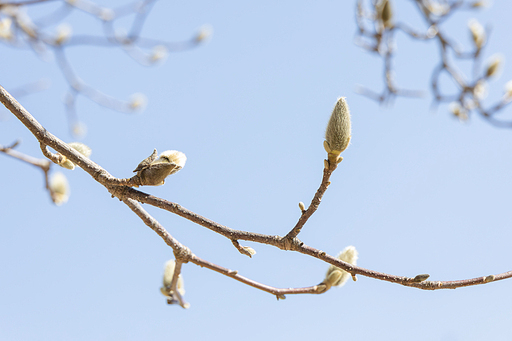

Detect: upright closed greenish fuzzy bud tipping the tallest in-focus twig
[324, 97, 351, 162]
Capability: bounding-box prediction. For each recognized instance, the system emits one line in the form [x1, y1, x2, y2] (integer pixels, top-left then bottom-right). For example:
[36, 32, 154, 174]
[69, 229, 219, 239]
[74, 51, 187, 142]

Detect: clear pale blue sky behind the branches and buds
[0, 1, 512, 341]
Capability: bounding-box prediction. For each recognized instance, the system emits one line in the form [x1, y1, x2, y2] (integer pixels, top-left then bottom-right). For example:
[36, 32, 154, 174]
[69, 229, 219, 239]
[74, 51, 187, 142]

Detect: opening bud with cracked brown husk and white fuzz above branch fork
[134, 149, 187, 186]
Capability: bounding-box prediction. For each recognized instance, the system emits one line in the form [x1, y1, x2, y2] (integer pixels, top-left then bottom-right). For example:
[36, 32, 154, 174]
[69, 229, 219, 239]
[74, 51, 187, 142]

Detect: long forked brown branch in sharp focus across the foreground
[0, 86, 512, 292]
